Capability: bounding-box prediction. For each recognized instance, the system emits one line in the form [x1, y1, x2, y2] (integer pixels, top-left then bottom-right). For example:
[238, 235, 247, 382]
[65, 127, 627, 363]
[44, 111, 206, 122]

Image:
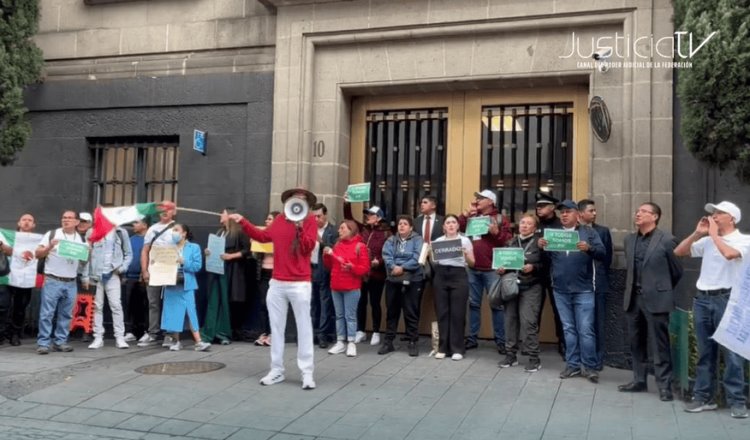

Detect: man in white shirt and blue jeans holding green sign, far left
[36, 211, 85, 354]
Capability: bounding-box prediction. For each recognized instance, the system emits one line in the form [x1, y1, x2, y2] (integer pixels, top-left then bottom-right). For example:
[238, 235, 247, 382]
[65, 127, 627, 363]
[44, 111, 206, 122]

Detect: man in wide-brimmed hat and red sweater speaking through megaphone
[229, 188, 318, 390]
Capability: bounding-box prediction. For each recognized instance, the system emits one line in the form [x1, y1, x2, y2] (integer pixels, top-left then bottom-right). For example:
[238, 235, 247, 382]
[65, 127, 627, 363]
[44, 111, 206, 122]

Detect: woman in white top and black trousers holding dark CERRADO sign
[432, 214, 474, 361]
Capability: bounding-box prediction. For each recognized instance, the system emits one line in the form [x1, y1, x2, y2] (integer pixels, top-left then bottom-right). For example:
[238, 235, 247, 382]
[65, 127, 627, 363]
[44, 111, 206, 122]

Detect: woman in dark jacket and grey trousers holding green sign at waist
[497, 214, 544, 373]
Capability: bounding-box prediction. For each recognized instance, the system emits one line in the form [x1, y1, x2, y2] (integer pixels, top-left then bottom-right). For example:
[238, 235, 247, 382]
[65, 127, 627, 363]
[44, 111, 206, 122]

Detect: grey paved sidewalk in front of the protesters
[0, 339, 750, 440]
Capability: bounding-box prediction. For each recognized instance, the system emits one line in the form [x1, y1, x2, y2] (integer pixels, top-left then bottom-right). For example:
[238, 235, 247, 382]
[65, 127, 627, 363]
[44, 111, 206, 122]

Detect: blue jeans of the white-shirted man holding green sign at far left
[37, 277, 78, 347]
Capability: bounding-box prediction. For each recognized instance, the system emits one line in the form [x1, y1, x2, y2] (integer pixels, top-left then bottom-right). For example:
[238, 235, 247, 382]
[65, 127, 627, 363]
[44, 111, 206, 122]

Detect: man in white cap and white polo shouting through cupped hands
[674, 201, 750, 418]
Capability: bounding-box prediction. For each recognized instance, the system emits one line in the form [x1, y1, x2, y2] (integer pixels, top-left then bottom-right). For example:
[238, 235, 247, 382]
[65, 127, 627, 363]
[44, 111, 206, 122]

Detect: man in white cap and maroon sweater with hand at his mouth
[458, 189, 512, 354]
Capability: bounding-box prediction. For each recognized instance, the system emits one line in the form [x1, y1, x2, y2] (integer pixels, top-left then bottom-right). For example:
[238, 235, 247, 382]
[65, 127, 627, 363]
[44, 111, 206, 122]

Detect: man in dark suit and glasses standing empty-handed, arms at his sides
[618, 202, 682, 402]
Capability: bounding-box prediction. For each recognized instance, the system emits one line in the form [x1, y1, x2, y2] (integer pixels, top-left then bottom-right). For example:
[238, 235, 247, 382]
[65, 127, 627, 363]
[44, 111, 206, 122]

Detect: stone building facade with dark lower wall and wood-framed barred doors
[0, 0, 692, 348]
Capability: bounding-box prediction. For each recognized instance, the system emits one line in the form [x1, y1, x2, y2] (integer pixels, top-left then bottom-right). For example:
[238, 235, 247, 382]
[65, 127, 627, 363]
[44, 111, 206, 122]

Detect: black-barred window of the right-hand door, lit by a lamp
[481, 103, 573, 221]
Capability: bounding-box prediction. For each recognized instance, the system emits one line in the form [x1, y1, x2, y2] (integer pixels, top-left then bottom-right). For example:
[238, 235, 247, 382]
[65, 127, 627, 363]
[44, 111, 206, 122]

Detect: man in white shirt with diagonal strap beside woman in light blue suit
[138, 200, 177, 347]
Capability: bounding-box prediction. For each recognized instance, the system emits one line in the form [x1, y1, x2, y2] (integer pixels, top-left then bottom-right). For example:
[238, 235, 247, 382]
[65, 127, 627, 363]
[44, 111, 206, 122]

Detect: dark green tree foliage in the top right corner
[675, 0, 750, 183]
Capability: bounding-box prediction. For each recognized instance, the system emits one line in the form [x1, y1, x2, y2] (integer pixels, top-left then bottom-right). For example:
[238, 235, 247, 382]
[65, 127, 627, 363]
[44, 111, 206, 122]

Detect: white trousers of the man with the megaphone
[266, 279, 314, 375]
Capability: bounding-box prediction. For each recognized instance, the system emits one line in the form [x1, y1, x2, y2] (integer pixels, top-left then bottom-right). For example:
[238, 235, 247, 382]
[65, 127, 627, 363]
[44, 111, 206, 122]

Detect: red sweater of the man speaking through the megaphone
[240, 214, 318, 281]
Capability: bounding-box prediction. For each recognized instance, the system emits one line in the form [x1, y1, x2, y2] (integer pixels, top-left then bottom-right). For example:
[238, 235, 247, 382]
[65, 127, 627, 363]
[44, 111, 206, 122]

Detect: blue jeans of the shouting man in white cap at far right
[693, 293, 745, 406]
